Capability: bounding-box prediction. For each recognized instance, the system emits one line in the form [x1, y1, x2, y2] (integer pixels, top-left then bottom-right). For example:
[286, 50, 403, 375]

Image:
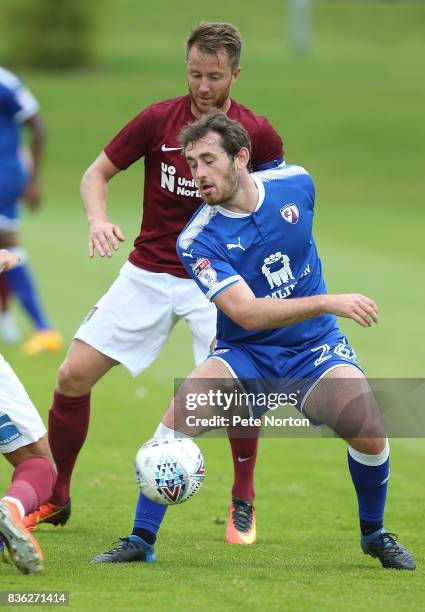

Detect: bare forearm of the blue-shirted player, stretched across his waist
[238, 295, 331, 330]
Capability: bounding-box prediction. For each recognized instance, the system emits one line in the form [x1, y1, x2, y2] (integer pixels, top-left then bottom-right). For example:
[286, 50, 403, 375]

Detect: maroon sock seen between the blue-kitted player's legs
[228, 427, 260, 503]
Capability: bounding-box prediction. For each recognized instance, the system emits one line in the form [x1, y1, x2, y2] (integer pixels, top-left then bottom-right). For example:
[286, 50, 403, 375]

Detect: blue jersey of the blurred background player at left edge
[0, 67, 39, 163]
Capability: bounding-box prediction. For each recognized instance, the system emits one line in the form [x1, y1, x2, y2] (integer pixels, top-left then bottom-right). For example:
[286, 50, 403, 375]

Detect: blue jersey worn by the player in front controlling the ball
[177, 165, 338, 349]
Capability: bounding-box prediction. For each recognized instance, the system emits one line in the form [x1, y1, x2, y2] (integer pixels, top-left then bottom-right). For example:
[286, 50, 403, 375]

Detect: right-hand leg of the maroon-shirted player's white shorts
[173, 279, 217, 365]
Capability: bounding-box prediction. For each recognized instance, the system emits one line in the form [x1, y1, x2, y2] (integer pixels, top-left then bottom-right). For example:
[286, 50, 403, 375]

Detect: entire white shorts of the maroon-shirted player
[74, 261, 217, 376]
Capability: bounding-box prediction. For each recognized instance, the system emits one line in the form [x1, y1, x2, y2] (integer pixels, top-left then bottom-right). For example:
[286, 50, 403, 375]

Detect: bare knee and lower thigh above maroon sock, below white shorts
[58, 340, 118, 396]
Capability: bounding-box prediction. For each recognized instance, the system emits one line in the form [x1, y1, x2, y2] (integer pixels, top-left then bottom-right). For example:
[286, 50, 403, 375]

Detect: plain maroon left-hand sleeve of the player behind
[104, 107, 156, 170]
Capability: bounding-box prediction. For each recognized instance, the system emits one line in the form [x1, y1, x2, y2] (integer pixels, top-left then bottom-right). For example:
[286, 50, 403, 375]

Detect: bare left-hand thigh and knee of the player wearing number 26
[163, 359, 237, 436]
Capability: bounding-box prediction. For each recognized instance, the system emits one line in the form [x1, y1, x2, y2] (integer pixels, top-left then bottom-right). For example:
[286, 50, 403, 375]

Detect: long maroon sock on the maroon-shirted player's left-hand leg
[49, 391, 90, 506]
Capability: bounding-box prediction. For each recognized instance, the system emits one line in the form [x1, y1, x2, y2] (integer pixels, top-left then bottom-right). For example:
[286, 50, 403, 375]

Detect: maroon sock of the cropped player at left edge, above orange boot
[6, 456, 56, 514]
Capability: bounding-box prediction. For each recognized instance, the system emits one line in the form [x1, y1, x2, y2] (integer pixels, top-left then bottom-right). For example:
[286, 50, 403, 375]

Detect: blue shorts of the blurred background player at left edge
[0, 159, 28, 231]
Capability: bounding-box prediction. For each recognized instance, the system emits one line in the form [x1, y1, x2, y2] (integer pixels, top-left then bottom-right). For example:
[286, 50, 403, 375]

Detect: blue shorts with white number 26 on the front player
[208, 329, 363, 418]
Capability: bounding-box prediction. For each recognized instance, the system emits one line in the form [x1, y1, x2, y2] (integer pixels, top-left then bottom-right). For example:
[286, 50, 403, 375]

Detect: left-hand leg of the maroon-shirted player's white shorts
[75, 262, 176, 376]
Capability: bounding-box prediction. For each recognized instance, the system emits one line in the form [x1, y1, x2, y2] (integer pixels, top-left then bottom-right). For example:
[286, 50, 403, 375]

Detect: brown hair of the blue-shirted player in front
[179, 108, 251, 159]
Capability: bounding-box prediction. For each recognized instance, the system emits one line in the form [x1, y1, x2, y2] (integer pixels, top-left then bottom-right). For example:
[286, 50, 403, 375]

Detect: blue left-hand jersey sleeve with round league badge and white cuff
[177, 242, 242, 302]
